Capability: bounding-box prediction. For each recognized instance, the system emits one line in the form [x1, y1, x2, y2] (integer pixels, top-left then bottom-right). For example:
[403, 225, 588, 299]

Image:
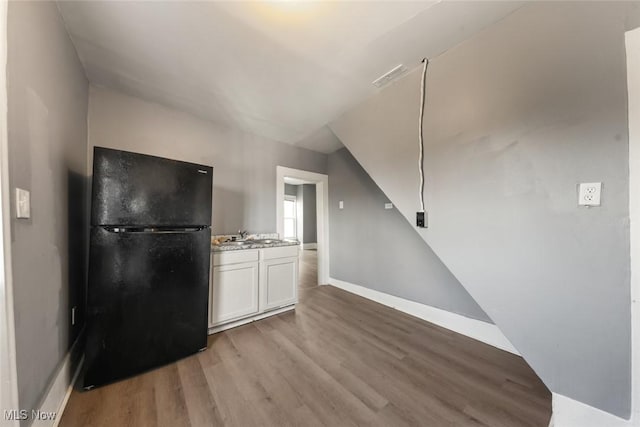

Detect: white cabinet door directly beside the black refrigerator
[209, 262, 258, 327]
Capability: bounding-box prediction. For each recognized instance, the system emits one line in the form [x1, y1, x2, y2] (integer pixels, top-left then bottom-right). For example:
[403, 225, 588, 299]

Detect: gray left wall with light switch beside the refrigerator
[7, 2, 88, 410]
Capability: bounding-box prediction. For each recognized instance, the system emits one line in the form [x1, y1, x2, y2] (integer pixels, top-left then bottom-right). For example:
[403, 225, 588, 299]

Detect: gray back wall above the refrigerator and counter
[89, 86, 327, 234]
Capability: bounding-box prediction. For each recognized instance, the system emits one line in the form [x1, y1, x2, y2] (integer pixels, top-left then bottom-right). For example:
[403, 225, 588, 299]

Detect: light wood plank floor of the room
[60, 251, 551, 427]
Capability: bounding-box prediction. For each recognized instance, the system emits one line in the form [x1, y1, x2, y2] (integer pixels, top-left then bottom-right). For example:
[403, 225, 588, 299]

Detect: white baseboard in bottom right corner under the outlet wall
[549, 393, 640, 427]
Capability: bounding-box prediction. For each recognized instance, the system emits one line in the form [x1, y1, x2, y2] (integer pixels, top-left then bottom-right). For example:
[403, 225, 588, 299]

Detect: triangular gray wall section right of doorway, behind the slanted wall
[329, 148, 491, 322]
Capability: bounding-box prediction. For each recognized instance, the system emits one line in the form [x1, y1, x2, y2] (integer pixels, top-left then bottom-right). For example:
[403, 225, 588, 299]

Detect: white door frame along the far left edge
[0, 1, 19, 426]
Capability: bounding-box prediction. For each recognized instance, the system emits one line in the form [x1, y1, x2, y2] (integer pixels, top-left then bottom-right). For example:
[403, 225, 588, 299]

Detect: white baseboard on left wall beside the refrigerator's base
[29, 333, 84, 427]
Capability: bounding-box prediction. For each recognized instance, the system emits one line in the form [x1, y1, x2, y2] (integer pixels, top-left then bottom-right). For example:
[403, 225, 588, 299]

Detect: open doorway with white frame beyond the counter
[276, 166, 329, 286]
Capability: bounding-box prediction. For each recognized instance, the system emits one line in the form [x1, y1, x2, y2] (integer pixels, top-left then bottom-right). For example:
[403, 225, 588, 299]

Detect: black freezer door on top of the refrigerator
[91, 147, 213, 227]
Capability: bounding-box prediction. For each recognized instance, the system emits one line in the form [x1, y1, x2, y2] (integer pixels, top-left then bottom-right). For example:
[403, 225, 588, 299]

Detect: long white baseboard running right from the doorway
[329, 278, 520, 356]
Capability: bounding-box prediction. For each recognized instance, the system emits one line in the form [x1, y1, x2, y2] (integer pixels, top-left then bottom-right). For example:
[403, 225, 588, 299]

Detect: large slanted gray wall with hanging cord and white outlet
[331, 2, 637, 417]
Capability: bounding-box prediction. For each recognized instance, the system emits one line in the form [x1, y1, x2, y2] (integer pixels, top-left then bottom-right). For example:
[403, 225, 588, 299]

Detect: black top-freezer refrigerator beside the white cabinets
[84, 147, 213, 389]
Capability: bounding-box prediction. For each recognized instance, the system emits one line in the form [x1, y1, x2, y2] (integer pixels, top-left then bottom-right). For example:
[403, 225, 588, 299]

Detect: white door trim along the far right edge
[625, 28, 640, 425]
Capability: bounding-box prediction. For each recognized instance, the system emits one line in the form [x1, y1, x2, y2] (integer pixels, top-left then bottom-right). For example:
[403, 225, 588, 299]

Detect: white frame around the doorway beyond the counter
[276, 166, 329, 285]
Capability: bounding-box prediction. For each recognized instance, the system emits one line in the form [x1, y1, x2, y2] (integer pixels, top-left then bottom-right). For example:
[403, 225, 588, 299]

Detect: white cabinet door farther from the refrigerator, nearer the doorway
[260, 258, 298, 311]
